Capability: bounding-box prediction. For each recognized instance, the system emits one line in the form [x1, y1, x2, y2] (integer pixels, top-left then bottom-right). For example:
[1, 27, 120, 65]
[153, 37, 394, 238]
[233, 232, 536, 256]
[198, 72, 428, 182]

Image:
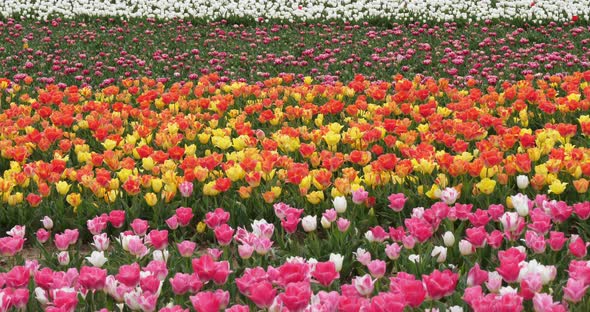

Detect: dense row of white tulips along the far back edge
[0, 0, 590, 23]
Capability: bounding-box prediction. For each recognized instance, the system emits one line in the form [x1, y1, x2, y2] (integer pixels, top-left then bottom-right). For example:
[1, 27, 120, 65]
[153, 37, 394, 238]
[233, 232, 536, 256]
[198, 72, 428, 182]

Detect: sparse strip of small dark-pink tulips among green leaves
[0, 18, 590, 88]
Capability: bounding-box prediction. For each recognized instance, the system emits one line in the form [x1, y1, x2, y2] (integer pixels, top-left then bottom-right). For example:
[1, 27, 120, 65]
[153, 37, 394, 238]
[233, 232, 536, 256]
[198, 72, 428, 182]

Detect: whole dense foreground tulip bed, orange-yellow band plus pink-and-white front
[0, 72, 590, 311]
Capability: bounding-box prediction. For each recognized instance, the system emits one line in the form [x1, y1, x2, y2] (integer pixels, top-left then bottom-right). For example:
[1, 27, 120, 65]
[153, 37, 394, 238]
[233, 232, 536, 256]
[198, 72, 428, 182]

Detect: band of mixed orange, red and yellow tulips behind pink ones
[0, 73, 590, 230]
